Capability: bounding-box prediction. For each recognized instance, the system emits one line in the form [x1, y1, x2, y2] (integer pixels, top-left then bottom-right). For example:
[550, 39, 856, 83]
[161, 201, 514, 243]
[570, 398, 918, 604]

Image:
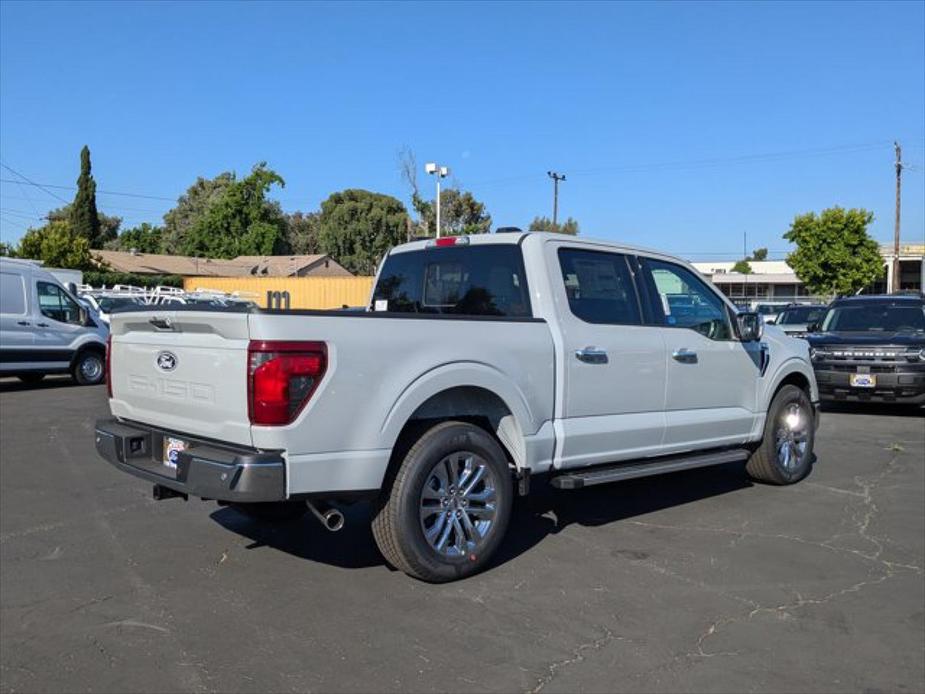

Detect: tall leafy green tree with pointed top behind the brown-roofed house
[178, 162, 286, 258]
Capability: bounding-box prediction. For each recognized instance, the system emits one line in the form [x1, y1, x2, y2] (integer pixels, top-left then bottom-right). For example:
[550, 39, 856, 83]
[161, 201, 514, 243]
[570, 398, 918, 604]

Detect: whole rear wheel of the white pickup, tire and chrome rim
[373, 422, 513, 583]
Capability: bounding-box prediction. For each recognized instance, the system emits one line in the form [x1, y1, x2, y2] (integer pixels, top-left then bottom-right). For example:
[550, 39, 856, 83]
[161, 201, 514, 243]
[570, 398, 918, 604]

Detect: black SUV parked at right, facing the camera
[806, 295, 925, 404]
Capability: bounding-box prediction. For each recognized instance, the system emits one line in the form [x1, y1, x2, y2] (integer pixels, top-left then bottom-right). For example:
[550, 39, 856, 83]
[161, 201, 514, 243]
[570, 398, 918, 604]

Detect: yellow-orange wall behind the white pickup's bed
[183, 277, 375, 309]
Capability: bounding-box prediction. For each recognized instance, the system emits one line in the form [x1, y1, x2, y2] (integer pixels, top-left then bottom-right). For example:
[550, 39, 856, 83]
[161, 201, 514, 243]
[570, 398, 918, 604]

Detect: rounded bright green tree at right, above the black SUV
[784, 207, 884, 295]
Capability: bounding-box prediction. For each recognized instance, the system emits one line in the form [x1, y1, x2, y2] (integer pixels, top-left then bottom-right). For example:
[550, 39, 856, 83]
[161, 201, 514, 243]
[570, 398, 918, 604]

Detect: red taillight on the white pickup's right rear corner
[247, 340, 328, 426]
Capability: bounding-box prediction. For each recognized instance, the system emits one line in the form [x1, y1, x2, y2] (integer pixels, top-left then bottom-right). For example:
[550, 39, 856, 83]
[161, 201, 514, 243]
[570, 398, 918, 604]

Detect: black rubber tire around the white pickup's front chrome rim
[745, 385, 816, 484]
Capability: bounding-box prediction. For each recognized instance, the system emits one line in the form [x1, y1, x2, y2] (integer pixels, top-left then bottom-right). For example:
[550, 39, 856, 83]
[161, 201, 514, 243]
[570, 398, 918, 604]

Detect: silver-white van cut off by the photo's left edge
[0, 258, 109, 385]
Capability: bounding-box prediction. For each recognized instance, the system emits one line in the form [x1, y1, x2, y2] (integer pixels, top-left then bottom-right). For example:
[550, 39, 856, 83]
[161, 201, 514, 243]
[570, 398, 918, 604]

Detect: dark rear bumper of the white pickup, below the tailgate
[96, 419, 286, 503]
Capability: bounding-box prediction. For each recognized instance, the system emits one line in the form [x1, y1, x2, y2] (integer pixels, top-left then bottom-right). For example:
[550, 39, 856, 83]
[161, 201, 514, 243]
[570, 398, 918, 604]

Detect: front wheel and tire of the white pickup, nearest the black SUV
[745, 385, 816, 484]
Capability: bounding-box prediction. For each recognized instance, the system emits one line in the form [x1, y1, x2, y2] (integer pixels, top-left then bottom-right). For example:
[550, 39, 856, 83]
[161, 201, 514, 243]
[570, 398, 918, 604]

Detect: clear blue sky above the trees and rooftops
[0, 2, 925, 259]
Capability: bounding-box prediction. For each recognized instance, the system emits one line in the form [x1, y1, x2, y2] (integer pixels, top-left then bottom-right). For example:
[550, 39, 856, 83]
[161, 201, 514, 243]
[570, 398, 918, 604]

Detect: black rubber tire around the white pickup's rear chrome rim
[372, 421, 513, 583]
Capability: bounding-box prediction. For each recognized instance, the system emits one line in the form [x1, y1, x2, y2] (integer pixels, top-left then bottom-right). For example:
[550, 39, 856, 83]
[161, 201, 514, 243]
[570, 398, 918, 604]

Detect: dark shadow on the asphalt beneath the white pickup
[211, 463, 752, 571]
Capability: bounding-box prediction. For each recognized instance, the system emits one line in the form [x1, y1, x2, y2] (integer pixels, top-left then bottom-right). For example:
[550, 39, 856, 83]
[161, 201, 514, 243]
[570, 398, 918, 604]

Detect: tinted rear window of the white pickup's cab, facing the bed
[372, 244, 533, 318]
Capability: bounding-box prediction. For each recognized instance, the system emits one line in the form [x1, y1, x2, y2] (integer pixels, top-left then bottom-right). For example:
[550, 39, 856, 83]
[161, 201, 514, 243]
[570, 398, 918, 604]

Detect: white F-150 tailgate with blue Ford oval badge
[110, 311, 251, 446]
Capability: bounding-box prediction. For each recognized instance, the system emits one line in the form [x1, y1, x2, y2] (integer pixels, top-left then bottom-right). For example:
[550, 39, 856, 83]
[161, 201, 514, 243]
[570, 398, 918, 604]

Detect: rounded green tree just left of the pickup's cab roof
[318, 188, 408, 275]
